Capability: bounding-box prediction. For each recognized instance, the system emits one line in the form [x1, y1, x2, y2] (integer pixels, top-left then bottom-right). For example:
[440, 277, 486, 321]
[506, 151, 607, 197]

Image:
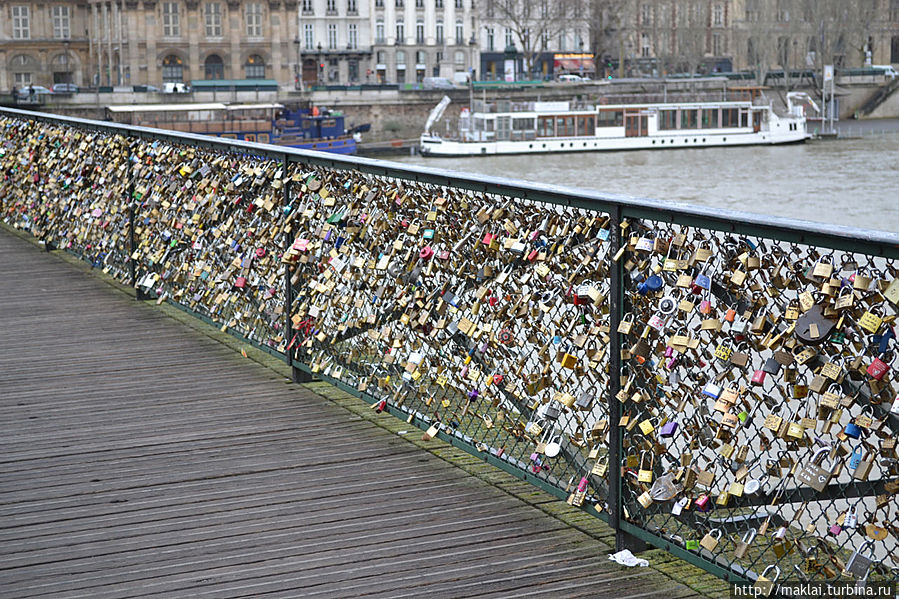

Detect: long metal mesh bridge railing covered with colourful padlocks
[0, 105, 899, 586]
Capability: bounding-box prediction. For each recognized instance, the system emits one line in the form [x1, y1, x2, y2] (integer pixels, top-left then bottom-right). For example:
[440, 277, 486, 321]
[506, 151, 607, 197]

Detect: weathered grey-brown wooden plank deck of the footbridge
[0, 229, 724, 599]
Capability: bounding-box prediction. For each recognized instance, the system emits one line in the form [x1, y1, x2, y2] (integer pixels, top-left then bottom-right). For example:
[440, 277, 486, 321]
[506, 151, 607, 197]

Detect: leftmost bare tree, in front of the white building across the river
[481, 0, 578, 77]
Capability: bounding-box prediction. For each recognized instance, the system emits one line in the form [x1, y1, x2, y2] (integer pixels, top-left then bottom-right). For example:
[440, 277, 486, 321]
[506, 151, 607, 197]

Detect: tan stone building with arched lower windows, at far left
[0, 0, 299, 89]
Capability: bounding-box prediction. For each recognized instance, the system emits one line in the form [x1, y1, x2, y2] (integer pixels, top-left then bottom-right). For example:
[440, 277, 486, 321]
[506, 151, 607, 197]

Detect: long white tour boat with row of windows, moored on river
[421, 92, 817, 156]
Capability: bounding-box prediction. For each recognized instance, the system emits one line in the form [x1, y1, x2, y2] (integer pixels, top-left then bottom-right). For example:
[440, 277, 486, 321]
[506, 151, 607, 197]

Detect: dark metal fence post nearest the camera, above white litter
[608, 205, 648, 551]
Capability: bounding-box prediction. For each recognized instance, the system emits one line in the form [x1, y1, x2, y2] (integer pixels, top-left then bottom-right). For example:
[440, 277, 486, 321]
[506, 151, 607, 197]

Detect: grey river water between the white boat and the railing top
[396, 120, 899, 232]
